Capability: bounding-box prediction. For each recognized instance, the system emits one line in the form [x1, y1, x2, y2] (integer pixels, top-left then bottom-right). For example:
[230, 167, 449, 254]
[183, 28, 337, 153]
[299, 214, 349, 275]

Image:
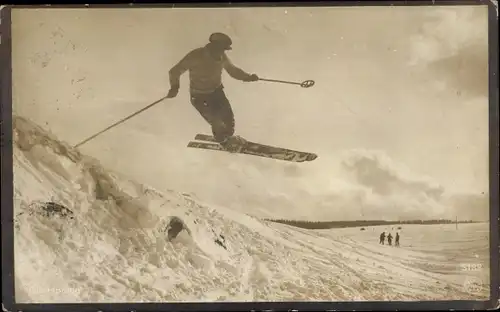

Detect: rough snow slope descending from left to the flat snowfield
[14, 116, 489, 303]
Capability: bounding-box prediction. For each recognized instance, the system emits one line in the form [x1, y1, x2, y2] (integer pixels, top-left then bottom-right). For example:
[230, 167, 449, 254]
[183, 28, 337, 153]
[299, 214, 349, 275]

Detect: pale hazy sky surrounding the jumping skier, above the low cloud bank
[12, 6, 488, 219]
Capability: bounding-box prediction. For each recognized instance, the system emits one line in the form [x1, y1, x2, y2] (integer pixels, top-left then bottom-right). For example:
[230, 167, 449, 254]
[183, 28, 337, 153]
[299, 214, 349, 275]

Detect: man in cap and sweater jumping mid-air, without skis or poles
[167, 33, 259, 146]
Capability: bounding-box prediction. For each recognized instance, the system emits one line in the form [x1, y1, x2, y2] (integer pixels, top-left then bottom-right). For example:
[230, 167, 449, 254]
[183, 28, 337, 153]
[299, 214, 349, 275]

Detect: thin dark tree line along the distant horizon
[264, 219, 479, 229]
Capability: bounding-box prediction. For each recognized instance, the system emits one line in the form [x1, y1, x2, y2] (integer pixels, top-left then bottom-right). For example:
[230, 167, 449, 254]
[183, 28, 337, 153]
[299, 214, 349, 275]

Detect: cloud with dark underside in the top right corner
[410, 6, 488, 97]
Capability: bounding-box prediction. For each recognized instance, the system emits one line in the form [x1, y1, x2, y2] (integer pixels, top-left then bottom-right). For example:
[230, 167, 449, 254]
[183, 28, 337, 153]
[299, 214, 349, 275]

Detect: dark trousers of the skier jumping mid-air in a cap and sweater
[191, 87, 234, 142]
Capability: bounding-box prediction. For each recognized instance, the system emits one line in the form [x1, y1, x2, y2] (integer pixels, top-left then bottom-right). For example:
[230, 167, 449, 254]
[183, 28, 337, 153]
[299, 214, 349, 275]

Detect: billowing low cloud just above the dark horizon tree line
[300, 150, 472, 220]
